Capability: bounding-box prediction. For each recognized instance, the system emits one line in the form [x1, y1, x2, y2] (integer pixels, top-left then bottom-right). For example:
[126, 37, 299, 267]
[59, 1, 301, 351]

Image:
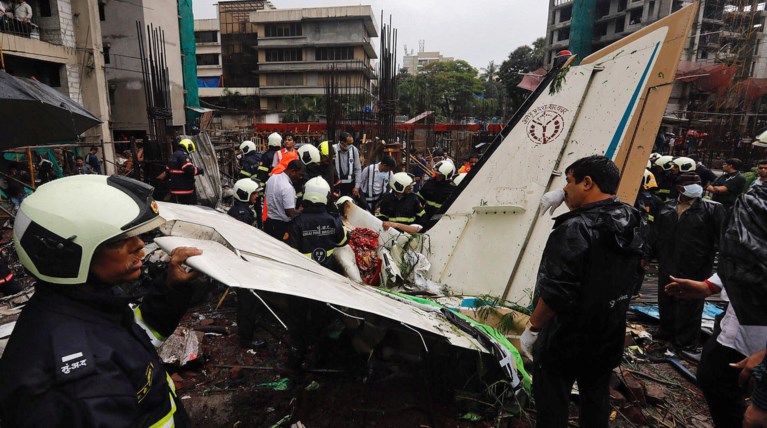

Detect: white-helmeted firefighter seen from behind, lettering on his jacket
[289, 177, 348, 269]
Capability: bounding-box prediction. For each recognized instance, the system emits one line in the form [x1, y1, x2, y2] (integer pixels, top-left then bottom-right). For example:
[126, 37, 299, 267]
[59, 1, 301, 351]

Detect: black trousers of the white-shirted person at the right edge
[697, 320, 746, 428]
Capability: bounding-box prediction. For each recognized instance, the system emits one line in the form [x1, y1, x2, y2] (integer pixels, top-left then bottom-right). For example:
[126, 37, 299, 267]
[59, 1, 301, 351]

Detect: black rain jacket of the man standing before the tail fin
[533, 197, 644, 374]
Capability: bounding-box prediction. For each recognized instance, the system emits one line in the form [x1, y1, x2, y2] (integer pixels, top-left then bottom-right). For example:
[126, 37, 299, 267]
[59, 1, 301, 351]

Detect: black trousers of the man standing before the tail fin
[533, 364, 612, 428]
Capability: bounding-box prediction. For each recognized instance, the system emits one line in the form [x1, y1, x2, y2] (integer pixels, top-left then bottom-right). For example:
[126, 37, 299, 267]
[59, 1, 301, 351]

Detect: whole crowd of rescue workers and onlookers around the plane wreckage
[0, 133, 767, 427]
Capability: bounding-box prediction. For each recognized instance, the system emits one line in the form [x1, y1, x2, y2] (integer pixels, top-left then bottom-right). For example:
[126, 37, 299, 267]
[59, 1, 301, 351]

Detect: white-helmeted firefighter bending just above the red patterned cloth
[375, 172, 425, 224]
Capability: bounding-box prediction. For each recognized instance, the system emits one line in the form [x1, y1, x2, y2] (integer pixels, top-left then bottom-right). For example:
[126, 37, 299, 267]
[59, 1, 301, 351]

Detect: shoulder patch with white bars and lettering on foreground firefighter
[51, 325, 96, 383]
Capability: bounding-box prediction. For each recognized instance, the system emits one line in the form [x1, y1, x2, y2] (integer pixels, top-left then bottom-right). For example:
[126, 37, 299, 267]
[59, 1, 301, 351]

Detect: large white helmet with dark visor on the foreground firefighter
[13, 175, 165, 284]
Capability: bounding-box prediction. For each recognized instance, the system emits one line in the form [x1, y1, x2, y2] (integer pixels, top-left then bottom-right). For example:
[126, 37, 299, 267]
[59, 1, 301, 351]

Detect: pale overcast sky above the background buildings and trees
[193, 0, 549, 69]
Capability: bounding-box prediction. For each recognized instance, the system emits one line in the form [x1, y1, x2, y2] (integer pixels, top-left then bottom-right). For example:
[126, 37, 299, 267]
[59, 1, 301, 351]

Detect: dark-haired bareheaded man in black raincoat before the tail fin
[520, 155, 644, 428]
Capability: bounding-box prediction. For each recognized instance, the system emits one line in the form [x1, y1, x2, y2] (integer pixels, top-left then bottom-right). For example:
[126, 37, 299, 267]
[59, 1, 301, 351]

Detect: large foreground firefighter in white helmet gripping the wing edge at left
[0, 175, 202, 427]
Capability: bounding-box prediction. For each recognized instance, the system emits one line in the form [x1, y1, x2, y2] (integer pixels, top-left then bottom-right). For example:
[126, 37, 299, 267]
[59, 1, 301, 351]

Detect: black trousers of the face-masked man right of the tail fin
[658, 275, 704, 349]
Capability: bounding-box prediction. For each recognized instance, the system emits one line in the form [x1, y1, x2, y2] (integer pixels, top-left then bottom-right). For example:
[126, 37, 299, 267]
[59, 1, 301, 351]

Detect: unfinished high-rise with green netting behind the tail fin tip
[545, 0, 767, 162]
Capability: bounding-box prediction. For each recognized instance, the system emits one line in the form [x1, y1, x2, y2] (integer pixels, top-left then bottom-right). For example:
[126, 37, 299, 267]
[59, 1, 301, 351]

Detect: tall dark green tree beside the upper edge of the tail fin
[498, 37, 546, 111]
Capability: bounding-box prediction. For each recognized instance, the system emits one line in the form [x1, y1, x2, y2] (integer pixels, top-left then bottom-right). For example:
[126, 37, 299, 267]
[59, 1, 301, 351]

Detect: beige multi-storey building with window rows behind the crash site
[195, 0, 378, 121]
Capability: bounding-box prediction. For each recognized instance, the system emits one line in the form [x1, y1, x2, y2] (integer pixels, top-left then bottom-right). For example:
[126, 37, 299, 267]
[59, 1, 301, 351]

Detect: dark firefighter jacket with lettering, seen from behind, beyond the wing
[289, 204, 349, 267]
